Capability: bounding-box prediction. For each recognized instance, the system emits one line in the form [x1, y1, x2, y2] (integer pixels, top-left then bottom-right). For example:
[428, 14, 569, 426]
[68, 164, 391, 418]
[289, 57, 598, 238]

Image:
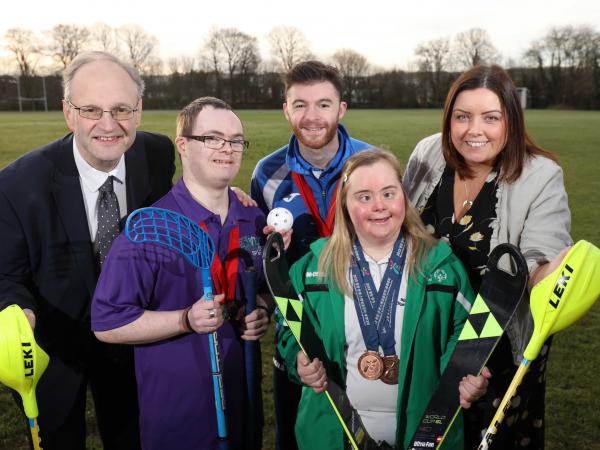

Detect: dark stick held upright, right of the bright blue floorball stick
[240, 266, 258, 449]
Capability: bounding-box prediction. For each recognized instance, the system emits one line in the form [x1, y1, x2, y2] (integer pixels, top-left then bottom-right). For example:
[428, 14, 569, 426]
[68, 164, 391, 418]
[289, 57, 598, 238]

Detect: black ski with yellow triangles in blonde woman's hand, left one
[263, 233, 392, 450]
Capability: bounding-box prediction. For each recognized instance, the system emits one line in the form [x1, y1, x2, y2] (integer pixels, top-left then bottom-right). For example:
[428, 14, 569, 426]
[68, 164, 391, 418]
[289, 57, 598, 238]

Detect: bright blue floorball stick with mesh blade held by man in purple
[125, 208, 228, 450]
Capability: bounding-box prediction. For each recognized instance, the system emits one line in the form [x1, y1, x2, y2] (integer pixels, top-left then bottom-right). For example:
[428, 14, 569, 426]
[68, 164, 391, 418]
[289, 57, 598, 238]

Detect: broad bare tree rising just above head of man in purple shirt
[204, 28, 260, 103]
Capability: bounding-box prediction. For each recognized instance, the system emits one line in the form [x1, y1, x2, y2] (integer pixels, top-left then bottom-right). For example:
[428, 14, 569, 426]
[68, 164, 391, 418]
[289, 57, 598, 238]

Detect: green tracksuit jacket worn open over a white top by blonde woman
[277, 239, 474, 450]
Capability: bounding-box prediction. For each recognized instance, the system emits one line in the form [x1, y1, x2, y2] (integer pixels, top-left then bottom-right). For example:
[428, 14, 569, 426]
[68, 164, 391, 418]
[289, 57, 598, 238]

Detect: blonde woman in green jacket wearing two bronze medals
[278, 150, 487, 450]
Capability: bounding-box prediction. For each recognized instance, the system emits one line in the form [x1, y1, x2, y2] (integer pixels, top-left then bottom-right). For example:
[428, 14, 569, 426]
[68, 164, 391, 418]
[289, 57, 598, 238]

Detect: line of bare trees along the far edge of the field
[0, 24, 600, 110]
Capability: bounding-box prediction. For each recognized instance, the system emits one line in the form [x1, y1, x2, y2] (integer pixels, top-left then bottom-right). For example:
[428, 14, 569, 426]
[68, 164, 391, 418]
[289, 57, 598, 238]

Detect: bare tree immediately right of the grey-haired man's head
[118, 25, 160, 73]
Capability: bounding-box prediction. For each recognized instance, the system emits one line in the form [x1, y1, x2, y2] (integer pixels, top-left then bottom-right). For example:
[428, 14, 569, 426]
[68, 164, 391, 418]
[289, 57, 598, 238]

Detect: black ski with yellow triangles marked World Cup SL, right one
[408, 244, 528, 450]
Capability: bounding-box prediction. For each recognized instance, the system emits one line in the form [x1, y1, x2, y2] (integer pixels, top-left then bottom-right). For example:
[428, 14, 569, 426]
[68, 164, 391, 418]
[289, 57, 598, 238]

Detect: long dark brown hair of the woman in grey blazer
[442, 64, 557, 183]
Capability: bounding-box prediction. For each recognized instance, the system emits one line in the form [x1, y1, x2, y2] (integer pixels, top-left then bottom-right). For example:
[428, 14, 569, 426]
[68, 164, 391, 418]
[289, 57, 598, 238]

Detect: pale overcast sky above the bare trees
[0, 0, 600, 69]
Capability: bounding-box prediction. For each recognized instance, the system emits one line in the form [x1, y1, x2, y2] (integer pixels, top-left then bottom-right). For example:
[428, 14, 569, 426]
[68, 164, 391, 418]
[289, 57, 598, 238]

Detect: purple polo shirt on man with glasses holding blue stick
[92, 179, 265, 450]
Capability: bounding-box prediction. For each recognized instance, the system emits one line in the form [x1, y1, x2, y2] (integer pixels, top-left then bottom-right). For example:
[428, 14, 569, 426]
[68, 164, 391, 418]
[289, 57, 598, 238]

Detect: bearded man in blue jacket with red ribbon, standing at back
[251, 61, 371, 450]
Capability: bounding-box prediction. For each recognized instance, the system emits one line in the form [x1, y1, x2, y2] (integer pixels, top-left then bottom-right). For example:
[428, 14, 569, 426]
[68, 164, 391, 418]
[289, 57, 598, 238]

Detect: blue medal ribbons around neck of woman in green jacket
[351, 234, 406, 356]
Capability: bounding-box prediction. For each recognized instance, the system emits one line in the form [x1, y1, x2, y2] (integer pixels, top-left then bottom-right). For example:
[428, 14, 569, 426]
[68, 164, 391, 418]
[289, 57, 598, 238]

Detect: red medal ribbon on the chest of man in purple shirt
[200, 222, 240, 303]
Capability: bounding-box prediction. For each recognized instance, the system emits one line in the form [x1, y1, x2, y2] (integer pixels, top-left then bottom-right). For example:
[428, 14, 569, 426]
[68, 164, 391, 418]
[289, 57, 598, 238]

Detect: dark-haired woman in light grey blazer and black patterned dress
[403, 65, 572, 449]
